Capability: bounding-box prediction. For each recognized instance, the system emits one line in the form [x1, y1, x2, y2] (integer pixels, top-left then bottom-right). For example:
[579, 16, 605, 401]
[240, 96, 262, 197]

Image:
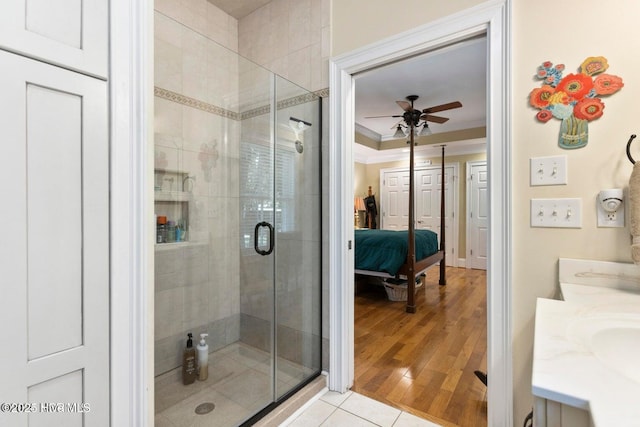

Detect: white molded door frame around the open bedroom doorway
[328, 0, 513, 426]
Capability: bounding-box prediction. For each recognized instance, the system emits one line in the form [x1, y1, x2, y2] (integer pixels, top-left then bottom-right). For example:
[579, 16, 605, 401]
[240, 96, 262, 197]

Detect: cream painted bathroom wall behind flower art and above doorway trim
[332, 0, 640, 425]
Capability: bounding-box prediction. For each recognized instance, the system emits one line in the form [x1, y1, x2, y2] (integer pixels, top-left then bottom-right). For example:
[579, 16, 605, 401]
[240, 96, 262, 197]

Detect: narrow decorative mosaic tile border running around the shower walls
[153, 86, 329, 120]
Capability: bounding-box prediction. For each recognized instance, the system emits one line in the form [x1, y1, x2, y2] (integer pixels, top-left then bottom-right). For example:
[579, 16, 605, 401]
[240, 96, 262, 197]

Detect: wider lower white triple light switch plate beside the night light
[531, 199, 582, 228]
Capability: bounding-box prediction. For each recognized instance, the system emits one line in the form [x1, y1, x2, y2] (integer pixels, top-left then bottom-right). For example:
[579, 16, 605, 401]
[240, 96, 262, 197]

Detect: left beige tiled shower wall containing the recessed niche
[154, 0, 240, 374]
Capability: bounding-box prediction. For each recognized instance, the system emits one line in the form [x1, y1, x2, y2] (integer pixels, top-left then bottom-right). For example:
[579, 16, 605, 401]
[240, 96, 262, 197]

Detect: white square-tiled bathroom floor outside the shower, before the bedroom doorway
[282, 391, 439, 427]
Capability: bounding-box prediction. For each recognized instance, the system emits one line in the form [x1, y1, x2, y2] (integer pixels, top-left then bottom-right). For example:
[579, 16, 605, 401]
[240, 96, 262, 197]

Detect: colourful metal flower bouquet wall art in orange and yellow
[529, 56, 624, 149]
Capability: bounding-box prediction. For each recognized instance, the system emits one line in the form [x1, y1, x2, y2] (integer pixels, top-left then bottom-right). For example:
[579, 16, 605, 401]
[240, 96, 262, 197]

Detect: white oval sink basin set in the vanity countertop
[567, 316, 640, 384]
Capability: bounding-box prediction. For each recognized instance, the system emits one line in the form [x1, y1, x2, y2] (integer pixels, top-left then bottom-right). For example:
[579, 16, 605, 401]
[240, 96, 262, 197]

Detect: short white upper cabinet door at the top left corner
[0, 0, 109, 78]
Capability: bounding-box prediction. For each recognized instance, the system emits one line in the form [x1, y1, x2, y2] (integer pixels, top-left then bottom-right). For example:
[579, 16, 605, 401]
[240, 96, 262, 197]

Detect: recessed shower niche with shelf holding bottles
[154, 169, 193, 247]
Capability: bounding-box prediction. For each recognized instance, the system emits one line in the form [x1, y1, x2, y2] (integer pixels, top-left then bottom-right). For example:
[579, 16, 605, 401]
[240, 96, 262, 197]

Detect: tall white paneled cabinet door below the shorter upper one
[0, 51, 109, 427]
